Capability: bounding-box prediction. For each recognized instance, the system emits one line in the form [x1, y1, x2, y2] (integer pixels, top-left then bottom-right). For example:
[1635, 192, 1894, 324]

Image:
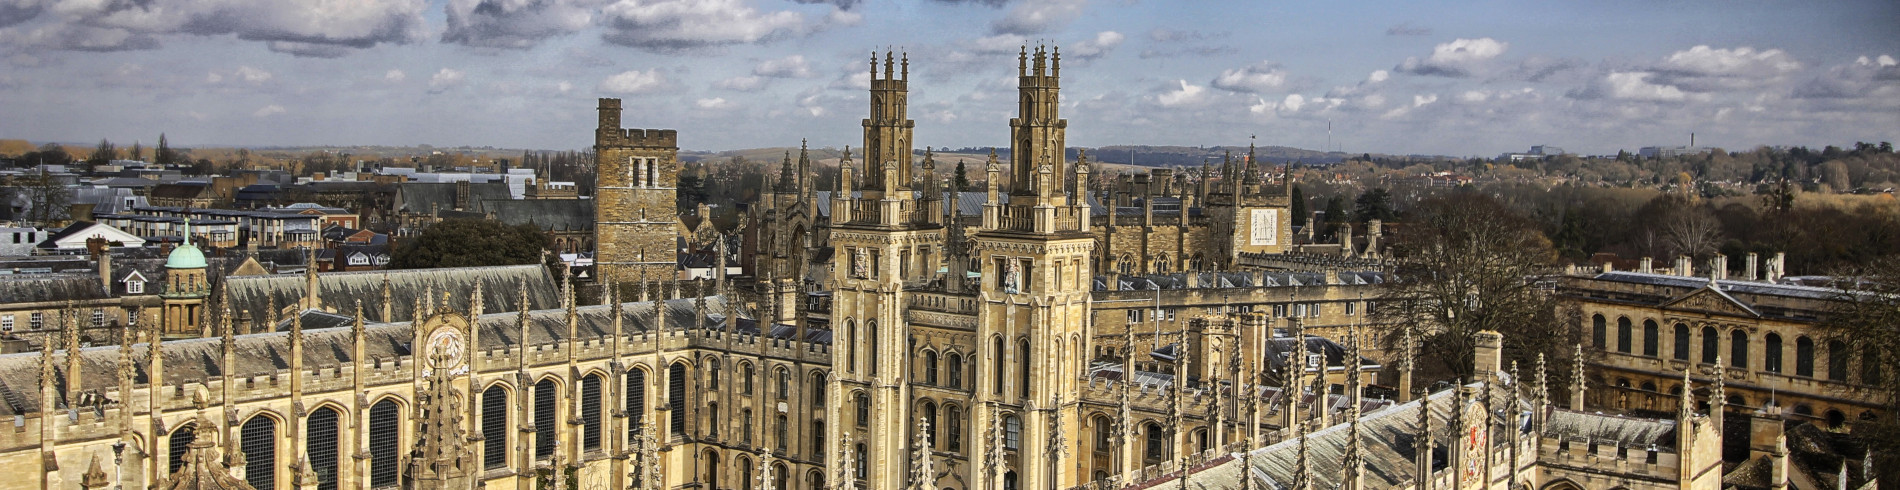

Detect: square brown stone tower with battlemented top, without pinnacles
[595, 99, 680, 281]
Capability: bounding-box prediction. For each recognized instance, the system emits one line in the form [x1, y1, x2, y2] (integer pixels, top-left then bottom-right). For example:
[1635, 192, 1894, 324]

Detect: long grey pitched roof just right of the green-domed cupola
[224, 264, 561, 323]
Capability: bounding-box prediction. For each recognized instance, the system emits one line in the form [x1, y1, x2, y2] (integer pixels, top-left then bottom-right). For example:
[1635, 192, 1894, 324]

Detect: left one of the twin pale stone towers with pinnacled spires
[827, 53, 942, 490]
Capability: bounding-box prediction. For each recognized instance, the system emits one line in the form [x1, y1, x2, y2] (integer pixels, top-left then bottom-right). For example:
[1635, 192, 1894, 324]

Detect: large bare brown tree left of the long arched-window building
[1372, 192, 1579, 382]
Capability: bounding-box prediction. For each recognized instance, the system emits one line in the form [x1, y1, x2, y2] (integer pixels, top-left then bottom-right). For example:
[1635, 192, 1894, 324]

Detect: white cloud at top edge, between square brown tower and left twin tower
[602, 0, 863, 51]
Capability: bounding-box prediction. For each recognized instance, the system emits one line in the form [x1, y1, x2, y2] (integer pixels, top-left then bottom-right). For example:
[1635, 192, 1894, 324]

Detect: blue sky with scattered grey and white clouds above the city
[0, 0, 1900, 156]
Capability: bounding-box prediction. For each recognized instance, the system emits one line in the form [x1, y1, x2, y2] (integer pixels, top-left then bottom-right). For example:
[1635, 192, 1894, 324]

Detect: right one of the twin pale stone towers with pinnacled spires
[971, 47, 1094, 488]
